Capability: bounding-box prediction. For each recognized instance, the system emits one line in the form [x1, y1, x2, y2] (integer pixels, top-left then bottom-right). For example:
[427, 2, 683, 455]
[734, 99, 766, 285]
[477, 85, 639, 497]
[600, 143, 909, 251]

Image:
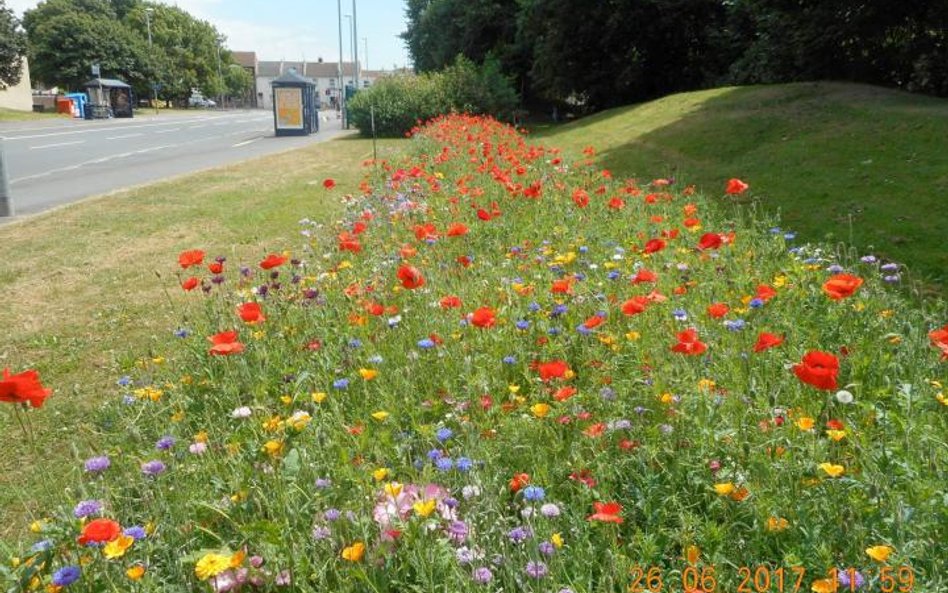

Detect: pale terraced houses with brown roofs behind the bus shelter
[252, 57, 392, 109]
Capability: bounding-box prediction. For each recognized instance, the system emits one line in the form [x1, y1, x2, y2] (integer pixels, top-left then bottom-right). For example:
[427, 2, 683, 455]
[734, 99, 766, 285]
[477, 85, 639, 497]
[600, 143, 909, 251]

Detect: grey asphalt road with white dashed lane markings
[0, 110, 346, 223]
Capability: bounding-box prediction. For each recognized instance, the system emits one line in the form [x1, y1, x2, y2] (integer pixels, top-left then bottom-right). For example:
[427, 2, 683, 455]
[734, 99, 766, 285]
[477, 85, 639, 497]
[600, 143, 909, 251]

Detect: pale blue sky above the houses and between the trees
[5, 0, 409, 70]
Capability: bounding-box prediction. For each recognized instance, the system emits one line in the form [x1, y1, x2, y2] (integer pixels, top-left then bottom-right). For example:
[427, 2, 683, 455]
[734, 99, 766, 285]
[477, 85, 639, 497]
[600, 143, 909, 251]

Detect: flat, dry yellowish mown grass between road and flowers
[0, 139, 397, 537]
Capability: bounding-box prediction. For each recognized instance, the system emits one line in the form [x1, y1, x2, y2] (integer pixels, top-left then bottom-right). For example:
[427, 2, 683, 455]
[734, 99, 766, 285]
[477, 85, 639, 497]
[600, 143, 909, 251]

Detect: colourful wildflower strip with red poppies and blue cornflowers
[0, 115, 948, 593]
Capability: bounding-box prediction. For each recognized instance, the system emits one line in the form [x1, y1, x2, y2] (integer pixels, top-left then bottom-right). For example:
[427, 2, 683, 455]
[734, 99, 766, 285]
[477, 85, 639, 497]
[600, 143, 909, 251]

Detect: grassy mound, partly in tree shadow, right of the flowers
[537, 83, 948, 295]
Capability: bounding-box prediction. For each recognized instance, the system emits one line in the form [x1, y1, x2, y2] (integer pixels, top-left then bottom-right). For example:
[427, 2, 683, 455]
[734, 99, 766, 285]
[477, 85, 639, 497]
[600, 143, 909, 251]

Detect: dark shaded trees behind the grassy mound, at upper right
[402, 0, 948, 109]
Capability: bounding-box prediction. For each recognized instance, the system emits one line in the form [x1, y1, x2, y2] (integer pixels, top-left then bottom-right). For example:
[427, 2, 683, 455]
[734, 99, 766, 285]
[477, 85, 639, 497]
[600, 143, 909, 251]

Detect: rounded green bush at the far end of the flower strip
[348, 56, 519, 137]
